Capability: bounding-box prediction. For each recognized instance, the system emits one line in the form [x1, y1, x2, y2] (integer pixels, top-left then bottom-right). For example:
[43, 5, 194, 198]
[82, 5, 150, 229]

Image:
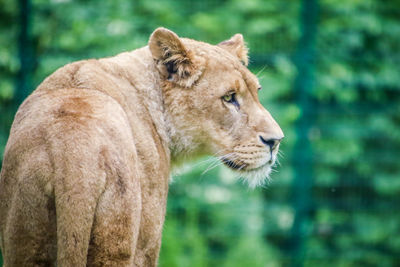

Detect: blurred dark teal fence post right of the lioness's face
[290, 0, 317, 266]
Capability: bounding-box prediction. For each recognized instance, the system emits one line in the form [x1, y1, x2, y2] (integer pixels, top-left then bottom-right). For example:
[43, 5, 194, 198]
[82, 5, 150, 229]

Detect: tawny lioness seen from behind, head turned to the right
[0, 28, 283, 267]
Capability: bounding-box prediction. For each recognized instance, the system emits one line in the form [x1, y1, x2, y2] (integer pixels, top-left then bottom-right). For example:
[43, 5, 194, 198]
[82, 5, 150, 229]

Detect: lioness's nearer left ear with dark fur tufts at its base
[149, 28, 204, 87]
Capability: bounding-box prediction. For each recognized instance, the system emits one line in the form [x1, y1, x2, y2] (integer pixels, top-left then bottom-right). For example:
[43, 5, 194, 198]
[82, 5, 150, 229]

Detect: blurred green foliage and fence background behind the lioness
[0, 0, 400, 267]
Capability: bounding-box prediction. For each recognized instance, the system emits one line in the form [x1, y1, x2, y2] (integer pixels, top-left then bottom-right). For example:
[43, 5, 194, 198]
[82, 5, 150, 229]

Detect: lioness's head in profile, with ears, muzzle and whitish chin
[149, 28, 284, 187]
